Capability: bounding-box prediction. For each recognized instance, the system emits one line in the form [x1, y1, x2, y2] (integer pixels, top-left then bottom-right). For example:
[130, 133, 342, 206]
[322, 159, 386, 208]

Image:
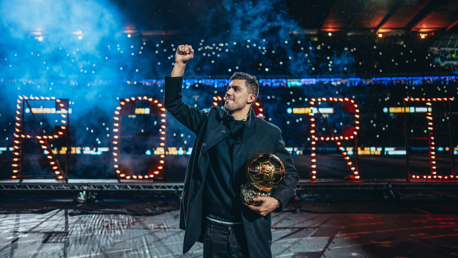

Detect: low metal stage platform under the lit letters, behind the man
[0, 179, 458, 192]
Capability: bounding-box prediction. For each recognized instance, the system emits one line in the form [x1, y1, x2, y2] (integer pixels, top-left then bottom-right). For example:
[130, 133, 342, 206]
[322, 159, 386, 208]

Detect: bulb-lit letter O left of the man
[113, 96, 166, 179]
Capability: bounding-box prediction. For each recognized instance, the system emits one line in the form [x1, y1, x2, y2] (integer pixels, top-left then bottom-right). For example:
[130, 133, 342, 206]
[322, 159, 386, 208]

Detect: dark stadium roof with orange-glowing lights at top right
[288, 0, 458, 34]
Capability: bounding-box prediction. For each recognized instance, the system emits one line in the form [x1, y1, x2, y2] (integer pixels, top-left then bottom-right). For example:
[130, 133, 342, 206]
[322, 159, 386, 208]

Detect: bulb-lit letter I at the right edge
[404, 98, 458, 179]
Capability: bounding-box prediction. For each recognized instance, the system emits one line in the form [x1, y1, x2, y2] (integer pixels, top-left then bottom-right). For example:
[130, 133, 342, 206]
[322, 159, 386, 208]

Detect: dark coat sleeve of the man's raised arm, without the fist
[164, 75, 207, 134]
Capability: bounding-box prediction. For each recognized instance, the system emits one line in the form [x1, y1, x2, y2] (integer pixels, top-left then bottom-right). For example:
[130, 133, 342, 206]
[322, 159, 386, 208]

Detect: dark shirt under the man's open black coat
[203, 117, 245, 222]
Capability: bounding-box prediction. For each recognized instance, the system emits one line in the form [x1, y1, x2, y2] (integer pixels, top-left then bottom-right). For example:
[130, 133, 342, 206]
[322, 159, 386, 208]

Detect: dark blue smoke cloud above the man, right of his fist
[190, 0, 355, 77]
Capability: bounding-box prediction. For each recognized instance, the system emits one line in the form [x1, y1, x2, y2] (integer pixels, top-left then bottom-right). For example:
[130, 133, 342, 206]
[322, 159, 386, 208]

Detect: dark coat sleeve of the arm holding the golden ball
[272, 131, 299, 212]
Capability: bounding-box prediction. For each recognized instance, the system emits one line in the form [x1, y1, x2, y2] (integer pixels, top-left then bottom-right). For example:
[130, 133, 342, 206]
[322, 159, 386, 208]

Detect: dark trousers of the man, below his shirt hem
[202, 220, 249, 258]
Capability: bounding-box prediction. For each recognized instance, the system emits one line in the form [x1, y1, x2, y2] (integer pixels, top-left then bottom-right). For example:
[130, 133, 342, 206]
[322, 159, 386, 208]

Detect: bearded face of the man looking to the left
[224, 79, 251, 112]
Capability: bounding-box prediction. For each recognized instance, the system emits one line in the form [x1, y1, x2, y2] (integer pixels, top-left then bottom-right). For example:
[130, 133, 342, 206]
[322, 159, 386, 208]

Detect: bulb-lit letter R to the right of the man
[309, 97, 360, 180]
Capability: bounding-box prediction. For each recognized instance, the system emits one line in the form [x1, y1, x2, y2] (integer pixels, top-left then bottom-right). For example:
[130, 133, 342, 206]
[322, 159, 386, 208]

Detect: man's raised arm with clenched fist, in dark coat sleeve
[164, 45, 205, 134]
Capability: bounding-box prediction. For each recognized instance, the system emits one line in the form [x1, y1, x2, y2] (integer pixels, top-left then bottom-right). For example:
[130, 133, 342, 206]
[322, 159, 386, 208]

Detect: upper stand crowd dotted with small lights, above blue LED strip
[0, 36, 450, 78]
